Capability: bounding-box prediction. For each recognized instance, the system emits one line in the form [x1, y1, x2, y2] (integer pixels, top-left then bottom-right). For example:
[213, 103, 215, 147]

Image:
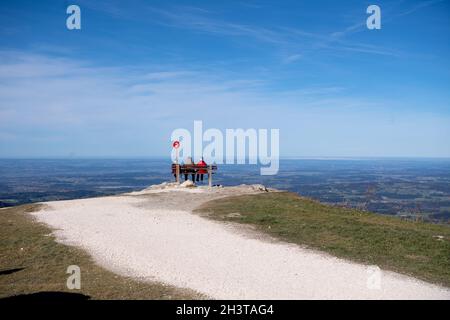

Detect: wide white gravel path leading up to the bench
[33, 184, 450, 299]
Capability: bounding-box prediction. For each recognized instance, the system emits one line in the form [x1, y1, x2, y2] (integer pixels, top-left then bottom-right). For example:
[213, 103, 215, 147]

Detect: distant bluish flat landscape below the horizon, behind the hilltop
[0, 158, 450, 223]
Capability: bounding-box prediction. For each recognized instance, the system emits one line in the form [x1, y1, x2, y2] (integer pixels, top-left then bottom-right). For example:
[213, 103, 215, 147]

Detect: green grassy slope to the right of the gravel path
[197, 192, 450, 287]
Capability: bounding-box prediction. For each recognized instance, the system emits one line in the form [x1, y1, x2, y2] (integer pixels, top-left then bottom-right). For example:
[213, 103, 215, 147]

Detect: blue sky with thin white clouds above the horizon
[0, 0, 450, 157]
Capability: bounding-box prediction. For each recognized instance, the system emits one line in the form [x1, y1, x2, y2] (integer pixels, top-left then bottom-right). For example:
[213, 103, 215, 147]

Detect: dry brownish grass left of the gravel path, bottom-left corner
[0, 204, 202, 299]
